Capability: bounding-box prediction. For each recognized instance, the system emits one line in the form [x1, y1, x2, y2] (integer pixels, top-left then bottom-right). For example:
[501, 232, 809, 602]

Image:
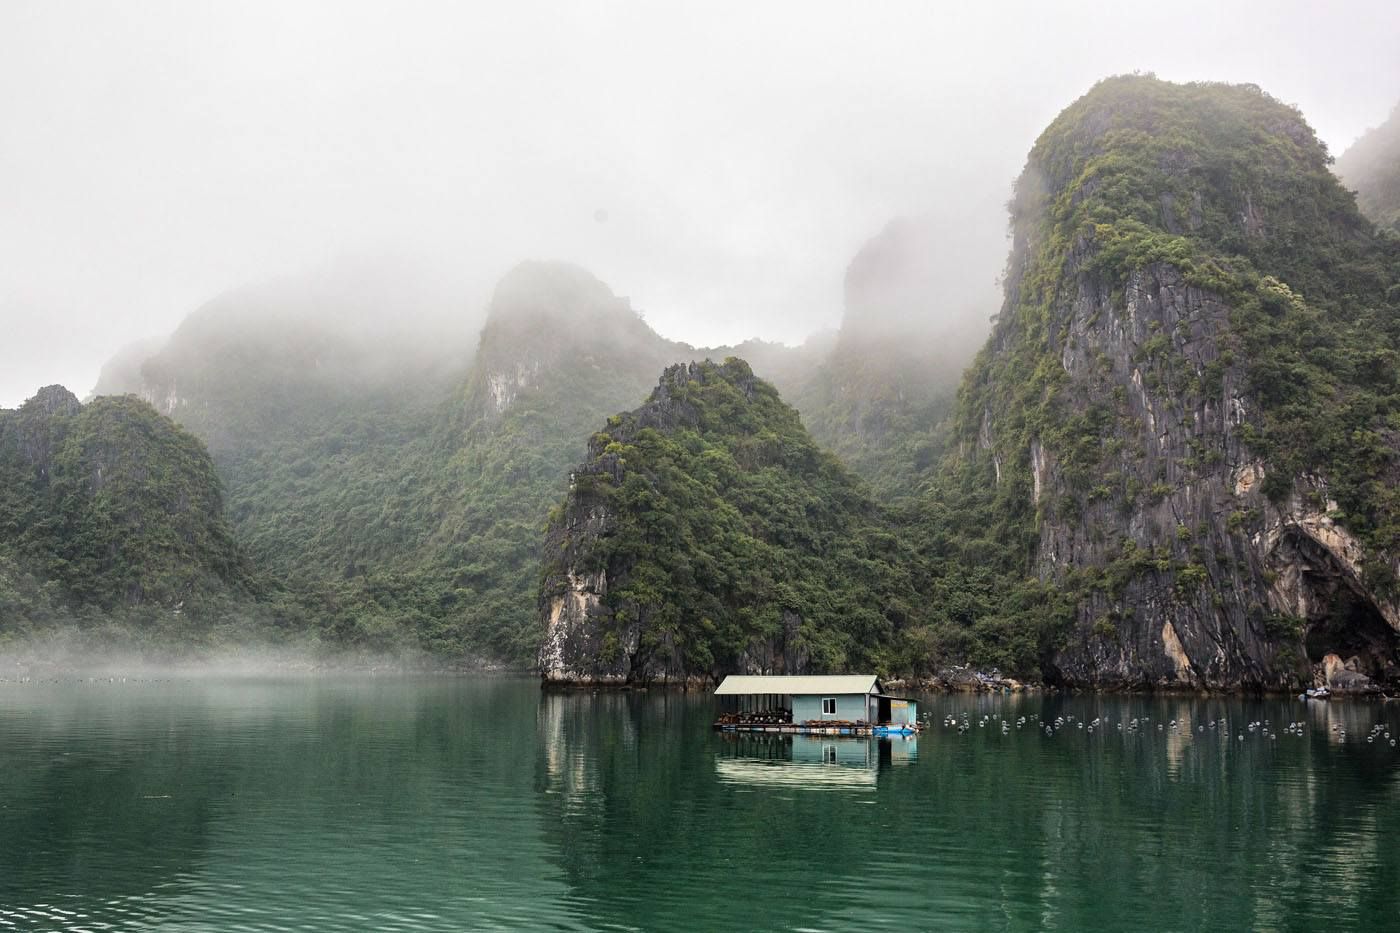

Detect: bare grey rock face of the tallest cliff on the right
[1019, 257, 1400, 688]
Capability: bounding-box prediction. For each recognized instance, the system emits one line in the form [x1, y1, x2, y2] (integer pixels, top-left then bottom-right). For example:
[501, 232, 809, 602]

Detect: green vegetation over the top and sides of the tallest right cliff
[958, 77, 1400, 546]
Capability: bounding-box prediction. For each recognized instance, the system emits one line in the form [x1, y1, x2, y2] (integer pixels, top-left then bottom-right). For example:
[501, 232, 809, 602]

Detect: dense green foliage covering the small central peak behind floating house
[554, 357, 935, 672]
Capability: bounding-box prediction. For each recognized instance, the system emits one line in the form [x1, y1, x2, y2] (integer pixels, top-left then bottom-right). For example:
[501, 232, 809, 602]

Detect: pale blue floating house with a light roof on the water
[714, 674, 918, 735]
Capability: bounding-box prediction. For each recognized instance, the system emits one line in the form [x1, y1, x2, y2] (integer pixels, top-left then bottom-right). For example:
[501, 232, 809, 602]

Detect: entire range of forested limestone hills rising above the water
[16, 76, 1400, 688]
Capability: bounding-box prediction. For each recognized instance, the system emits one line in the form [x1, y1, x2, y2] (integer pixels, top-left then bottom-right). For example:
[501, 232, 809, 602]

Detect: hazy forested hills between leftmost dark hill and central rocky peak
[73, 262, 816, 665]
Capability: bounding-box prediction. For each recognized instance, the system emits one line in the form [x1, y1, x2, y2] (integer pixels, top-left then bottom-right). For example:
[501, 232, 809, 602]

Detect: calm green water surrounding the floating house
[0, 678, 1400, 930]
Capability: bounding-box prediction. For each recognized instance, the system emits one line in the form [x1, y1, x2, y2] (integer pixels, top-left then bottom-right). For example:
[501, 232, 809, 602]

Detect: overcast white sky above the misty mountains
[0, 0, 1400, 406]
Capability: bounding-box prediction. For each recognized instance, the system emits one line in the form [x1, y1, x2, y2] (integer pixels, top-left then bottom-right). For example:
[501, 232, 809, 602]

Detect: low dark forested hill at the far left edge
[0, 385, 251, 635]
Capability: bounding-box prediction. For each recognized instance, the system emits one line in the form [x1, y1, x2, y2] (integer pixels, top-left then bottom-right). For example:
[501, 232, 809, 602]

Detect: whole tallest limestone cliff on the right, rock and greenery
[960, 78, 1400, 688]
